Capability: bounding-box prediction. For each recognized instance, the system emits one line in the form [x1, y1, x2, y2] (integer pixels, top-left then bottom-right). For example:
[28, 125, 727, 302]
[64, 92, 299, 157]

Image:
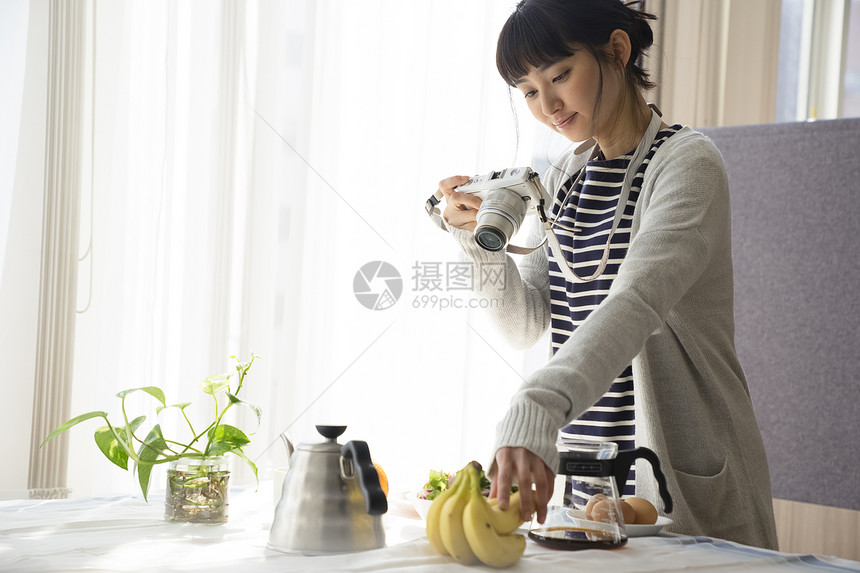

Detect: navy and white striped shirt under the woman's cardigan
[548, 124, 681, 495]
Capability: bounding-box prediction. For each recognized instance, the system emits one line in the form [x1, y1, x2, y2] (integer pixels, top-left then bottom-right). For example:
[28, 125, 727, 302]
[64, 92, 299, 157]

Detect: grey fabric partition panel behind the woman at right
[703, 119, 860, 510]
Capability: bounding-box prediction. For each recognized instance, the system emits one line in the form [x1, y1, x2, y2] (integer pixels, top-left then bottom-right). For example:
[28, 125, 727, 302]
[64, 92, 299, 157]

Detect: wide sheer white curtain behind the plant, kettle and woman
[68, 0, 546, 495]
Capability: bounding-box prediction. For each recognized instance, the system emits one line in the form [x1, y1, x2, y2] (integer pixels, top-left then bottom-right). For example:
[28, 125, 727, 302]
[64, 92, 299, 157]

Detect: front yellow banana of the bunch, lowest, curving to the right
[463, 470, 526, 567]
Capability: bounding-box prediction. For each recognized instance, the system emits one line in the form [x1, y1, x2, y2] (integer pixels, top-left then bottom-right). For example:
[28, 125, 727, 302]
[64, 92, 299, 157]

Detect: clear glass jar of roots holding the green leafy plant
[164, 456, 230, 524]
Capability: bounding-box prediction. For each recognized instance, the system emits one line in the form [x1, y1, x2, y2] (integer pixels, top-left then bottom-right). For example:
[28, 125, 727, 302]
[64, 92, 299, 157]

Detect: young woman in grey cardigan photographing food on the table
[439, 0, 777, 549]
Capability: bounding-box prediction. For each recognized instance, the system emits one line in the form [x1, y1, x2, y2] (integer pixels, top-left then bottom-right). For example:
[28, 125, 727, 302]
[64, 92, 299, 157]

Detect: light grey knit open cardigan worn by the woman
[452, 127, 777, 549]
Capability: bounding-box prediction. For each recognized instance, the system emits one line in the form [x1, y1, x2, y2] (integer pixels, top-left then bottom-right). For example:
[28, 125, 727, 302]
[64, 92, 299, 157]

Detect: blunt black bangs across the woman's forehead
[496, 5, 574, 86]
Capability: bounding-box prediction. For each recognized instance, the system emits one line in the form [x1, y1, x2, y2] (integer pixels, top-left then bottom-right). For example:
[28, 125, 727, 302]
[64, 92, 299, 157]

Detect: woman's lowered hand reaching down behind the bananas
[490, 448, 555, 523]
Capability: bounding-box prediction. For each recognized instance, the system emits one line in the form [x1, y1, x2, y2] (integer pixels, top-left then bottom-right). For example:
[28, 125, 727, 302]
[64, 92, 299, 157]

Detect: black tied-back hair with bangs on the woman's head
[496, 0, 656, 89]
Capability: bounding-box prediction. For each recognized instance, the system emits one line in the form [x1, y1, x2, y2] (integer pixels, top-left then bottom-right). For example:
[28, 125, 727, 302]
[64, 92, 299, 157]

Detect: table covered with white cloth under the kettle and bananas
[0, 482, 860, 573]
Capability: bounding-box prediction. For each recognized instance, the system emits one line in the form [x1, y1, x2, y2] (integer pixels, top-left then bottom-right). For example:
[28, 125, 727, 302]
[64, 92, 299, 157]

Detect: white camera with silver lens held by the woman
[457, 167, 549, 251]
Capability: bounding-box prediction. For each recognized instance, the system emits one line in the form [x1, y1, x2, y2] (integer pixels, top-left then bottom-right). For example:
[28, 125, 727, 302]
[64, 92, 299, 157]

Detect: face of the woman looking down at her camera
[515, 49, 616, 141]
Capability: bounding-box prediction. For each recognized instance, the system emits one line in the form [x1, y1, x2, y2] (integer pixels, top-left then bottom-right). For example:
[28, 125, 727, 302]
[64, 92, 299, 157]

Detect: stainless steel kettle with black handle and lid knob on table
[269, 426, 388, 553]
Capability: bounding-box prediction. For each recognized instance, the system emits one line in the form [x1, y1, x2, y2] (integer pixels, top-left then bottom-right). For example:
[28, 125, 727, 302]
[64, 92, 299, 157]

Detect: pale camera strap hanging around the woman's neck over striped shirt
[541, 106, 661, 283]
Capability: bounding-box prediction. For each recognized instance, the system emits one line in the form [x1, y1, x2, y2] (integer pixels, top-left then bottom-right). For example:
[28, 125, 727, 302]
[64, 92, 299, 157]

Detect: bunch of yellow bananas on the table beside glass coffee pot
[427, 462, 526, 567]
